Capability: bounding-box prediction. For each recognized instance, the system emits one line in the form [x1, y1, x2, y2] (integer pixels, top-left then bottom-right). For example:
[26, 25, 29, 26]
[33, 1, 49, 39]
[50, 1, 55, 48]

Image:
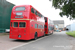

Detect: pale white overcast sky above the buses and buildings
[7, 0, 75, 27]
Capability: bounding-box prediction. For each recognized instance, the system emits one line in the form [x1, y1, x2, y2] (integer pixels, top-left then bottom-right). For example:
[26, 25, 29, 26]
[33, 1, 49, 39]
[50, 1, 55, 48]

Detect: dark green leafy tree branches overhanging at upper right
[50, 0, 75, 19]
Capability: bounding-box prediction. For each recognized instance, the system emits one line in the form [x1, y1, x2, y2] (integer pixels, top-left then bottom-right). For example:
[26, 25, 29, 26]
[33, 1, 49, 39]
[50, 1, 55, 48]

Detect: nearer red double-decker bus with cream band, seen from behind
[10, 5, 45, 40]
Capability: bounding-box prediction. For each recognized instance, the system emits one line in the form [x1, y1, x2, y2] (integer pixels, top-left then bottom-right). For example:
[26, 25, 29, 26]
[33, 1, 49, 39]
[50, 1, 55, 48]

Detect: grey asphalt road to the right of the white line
[12, 32, 75, 50]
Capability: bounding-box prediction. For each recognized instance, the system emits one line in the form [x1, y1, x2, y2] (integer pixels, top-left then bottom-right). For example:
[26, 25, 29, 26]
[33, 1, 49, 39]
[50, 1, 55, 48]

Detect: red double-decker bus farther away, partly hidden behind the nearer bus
[44, 17, 54, 35]
